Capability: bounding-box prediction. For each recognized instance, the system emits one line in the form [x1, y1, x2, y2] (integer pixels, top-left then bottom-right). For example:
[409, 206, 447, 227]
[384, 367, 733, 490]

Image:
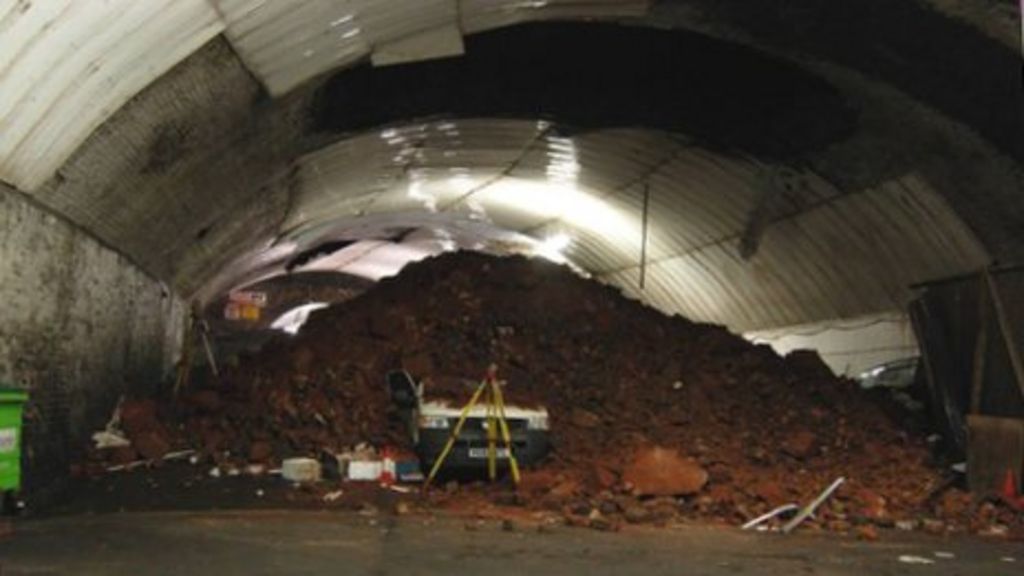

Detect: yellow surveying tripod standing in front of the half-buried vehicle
[423, 365, 519, 491]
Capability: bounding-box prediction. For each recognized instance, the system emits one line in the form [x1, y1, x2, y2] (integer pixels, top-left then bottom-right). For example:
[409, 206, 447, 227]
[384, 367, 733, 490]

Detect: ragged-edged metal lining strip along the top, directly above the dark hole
[211, 0, 649, 95]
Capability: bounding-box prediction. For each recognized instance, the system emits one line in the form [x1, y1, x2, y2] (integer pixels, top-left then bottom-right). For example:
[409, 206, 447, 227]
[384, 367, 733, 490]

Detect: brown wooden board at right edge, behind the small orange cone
[967, 414, 1024, 496]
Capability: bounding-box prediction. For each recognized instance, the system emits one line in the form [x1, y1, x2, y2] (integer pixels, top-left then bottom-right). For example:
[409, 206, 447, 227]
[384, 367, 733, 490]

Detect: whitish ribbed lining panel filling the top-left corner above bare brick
[0, 0, 222, 192]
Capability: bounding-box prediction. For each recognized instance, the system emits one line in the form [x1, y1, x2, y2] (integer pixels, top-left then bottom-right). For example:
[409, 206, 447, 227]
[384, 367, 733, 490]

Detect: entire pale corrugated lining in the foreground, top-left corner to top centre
[0, 0, 648, 192]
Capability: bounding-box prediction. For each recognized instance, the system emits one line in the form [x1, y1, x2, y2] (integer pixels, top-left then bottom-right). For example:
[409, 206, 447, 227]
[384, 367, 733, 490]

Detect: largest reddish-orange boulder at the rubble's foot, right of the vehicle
[623, 448, 708, 496]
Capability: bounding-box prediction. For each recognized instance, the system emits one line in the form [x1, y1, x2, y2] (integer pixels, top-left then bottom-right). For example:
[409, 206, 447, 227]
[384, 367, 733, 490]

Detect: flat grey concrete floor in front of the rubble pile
[0, 511, 1024, 576]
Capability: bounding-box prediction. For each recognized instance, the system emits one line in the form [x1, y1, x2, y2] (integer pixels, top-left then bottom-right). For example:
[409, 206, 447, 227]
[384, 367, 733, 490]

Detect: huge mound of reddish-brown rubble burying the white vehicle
[83, 253, 1024, 532]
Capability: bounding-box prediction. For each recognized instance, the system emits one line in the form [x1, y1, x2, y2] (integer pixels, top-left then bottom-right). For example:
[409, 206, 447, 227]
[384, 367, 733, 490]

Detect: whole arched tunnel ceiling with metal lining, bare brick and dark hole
[0, 0, 1024, 329]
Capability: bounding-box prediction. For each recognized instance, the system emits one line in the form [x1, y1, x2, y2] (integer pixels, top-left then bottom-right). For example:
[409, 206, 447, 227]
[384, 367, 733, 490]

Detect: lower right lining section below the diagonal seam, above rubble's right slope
[597, 174, 987, 330]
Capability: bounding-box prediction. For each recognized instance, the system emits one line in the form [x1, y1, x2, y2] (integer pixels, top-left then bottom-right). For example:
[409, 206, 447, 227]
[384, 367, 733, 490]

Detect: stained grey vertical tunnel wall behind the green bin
[0, 184, 186, 503]
